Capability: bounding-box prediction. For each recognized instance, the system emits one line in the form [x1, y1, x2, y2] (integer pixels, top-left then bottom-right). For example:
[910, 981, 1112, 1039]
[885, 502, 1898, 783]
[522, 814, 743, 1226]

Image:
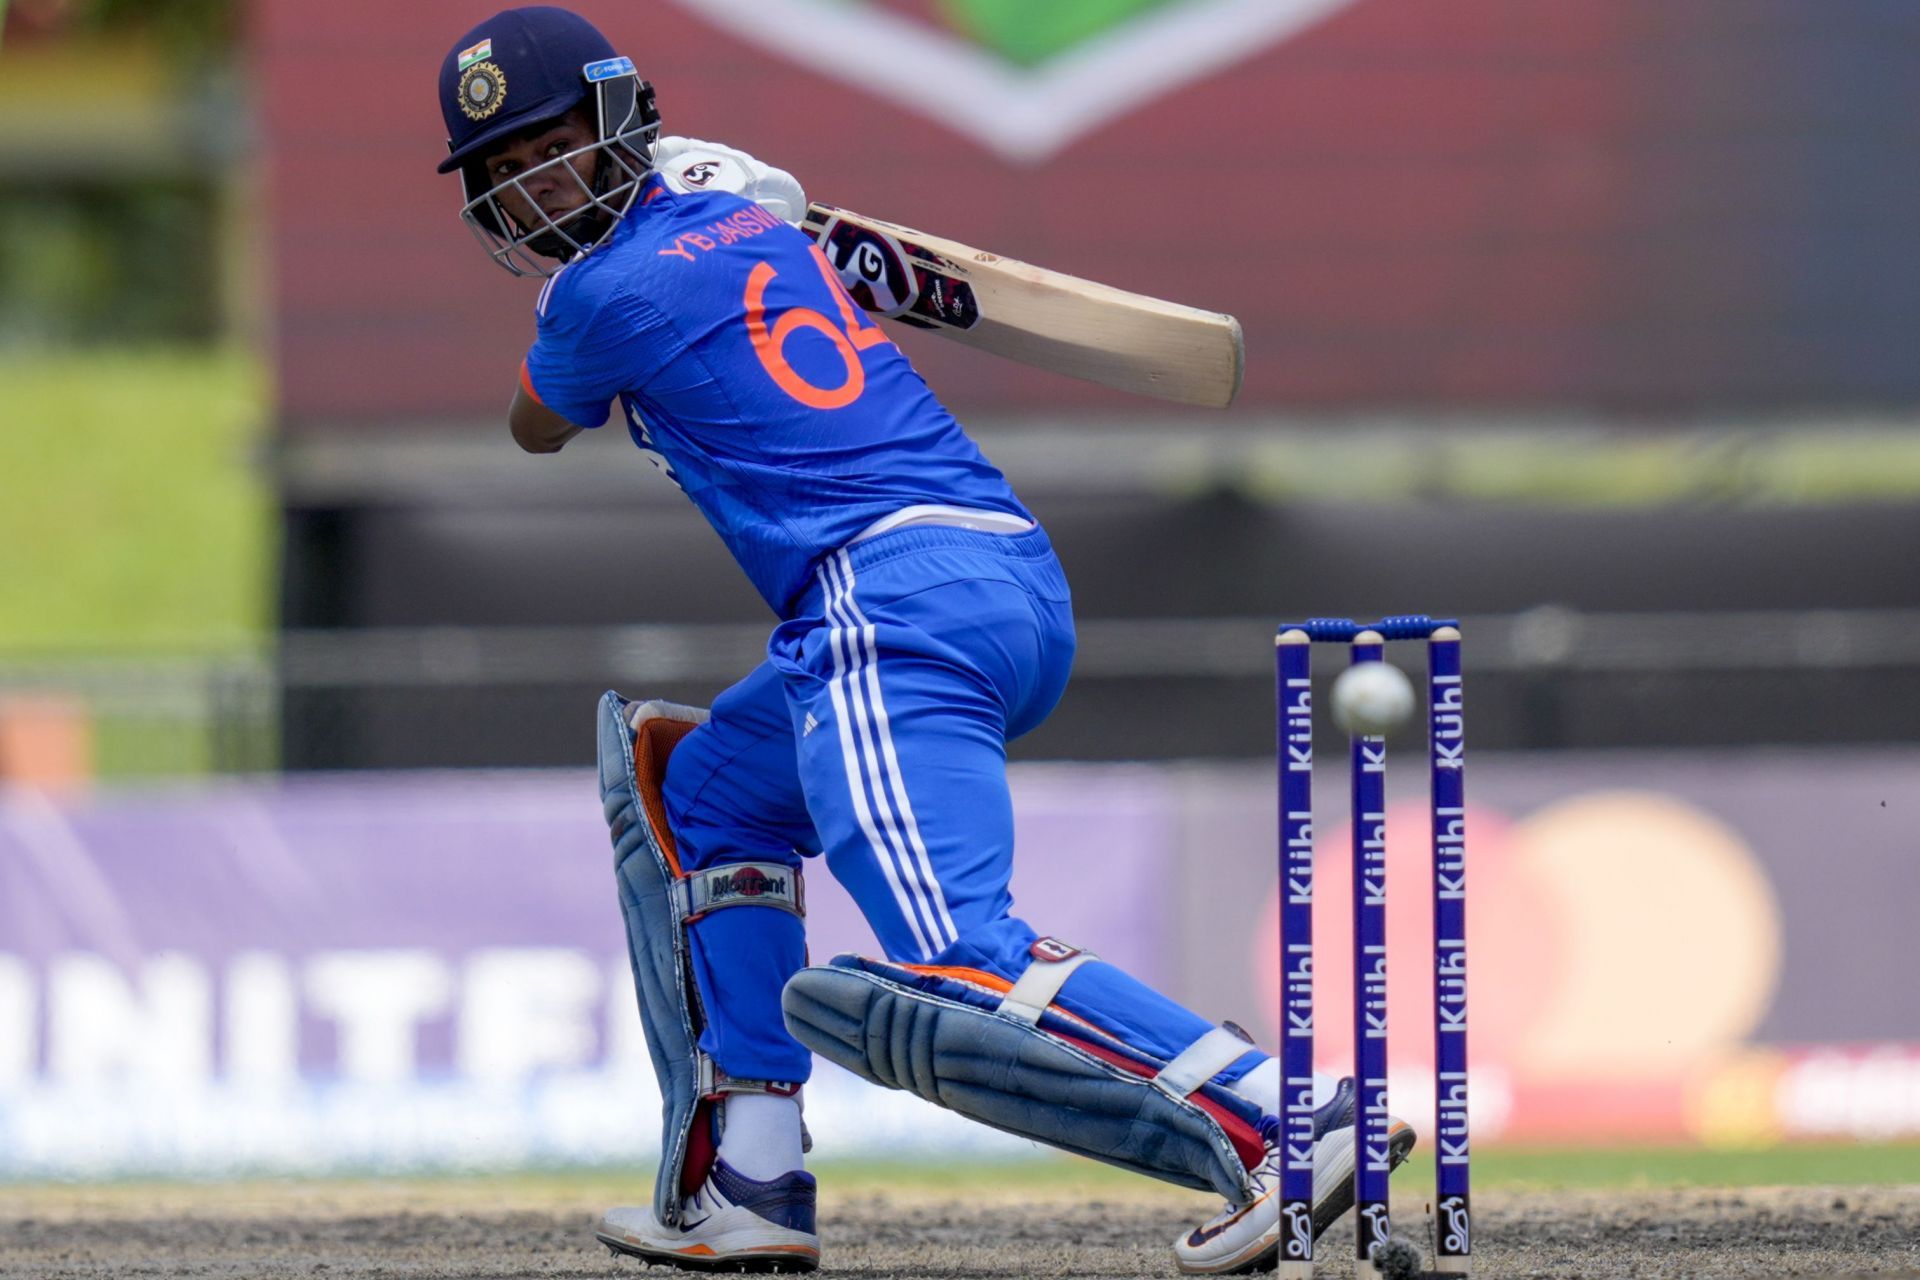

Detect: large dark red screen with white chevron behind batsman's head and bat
[255, 0, 1920, 426]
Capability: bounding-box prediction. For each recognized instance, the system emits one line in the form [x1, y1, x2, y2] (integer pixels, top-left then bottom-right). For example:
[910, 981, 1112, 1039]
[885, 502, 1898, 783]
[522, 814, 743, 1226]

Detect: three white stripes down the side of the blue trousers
[820, 551, 958, 960]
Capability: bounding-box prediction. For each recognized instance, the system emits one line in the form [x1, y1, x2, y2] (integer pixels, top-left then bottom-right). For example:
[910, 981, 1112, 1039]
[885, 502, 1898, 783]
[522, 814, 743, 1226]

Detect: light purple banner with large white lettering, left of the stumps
[0, 770, 1173, 1176]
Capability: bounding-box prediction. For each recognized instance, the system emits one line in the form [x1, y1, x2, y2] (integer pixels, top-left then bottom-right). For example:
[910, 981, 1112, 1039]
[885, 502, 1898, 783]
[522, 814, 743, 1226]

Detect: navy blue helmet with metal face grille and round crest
[440, 4, 660, 276]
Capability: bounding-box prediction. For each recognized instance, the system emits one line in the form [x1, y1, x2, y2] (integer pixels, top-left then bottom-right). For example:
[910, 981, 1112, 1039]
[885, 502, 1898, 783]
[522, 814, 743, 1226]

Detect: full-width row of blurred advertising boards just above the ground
[0, 750, 1920, 1178]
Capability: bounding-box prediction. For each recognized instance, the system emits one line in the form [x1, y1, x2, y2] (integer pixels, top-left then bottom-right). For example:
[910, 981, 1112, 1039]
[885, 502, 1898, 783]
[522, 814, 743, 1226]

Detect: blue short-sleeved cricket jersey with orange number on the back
[524, 175, 1031, 618]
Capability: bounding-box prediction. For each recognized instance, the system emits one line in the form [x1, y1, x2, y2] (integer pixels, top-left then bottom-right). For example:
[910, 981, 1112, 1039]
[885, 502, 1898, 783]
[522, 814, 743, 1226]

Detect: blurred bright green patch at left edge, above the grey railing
[0, 351, 275, 656]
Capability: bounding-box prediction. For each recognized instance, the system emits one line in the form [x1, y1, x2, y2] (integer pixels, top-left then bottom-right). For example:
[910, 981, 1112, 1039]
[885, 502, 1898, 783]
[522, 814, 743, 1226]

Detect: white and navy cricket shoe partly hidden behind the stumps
[1173, 1077, 1415, 1276]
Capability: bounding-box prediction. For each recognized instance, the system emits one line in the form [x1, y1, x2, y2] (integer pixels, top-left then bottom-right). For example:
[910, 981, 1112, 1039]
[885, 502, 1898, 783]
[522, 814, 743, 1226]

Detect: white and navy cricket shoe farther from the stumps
[593, 1159, 820, 1272]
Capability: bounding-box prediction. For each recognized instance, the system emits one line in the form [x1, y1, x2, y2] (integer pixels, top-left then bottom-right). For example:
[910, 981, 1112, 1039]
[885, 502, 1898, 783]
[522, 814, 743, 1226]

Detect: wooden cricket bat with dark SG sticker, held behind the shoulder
[803, 203, 1246, 409]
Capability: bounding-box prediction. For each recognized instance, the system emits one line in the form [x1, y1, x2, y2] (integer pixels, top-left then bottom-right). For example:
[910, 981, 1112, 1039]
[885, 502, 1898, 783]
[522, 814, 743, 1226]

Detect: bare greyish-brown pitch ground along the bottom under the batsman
[0, 1182, 1920, 1280]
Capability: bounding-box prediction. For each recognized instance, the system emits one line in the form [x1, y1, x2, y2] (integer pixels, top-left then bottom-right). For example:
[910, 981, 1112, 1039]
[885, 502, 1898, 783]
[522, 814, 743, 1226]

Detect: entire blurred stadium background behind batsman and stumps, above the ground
[0, 0, 1920, 1180]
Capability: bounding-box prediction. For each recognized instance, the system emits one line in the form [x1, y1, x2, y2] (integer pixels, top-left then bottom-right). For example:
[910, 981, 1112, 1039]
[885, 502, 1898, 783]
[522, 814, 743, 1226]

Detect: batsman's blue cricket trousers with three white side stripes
[664, 526, 1260, 1082]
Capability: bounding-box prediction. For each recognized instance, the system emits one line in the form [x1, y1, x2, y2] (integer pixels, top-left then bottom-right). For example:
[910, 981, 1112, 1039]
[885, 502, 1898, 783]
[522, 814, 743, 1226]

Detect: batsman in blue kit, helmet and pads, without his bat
[440, 6, 1413, 1274]
